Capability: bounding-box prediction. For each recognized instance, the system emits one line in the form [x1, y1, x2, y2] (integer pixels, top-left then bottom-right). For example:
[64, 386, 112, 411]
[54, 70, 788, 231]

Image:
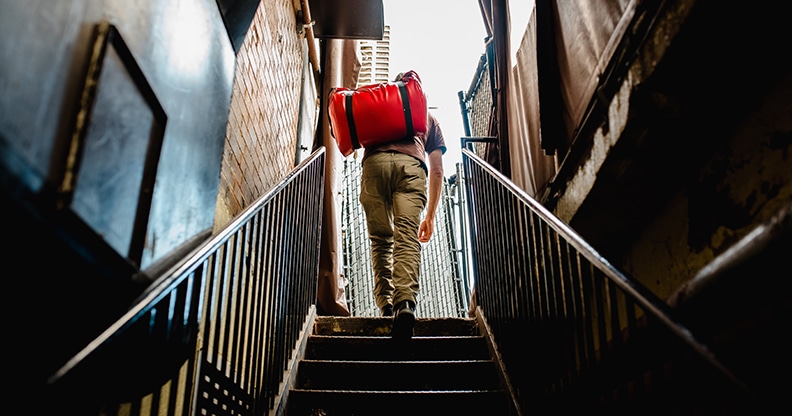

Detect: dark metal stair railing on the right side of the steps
[462, 149, 750, 414]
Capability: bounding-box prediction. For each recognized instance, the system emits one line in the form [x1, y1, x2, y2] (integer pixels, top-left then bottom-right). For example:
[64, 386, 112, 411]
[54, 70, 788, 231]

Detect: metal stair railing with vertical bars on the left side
[46, 148, 325, 415]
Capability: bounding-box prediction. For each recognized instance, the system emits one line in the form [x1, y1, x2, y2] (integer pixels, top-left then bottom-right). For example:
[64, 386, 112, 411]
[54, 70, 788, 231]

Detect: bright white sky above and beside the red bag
[383, 0, 533, 177]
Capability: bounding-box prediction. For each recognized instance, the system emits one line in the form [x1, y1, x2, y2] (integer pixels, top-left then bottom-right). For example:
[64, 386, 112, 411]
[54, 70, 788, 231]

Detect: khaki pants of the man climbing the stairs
[360, 152, 426, 309]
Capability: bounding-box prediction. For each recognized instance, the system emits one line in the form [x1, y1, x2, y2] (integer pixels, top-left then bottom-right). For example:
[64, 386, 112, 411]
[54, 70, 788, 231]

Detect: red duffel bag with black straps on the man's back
[328, 71, 427, 156]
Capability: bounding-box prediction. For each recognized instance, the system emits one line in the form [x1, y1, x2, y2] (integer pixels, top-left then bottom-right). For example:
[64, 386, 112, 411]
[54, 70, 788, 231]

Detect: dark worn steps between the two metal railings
[286, 317, 518, 416]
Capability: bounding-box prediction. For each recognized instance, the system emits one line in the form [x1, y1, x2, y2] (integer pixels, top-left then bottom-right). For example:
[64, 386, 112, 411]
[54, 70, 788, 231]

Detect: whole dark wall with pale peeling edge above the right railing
[555, 0, 792, 299]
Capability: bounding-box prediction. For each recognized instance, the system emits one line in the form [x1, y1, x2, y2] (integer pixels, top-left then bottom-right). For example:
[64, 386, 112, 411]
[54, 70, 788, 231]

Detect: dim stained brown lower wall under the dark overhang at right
[625, 76, 792, 299]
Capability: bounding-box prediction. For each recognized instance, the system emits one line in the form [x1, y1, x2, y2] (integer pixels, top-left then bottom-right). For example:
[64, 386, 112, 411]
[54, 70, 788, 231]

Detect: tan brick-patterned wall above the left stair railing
[214, 0, 305, 231]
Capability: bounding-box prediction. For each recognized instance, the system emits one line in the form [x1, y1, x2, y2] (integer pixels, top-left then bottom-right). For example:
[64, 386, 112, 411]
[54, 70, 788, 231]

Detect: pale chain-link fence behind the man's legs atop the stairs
[342, 157, 469, 318]
